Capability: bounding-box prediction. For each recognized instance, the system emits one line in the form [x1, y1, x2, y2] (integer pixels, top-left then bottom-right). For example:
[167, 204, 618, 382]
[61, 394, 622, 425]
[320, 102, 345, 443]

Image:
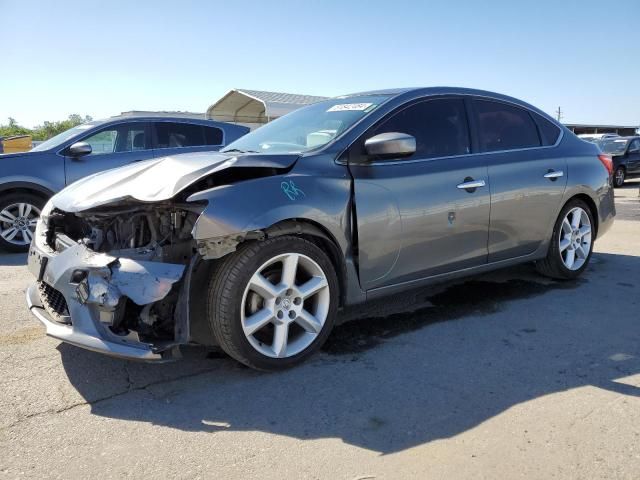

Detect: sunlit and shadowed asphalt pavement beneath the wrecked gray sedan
[0, 182, 640, 480]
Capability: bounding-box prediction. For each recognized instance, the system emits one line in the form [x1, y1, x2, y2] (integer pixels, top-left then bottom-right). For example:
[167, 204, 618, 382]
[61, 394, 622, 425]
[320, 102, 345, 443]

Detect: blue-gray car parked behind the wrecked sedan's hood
[0, 115, 249, 252]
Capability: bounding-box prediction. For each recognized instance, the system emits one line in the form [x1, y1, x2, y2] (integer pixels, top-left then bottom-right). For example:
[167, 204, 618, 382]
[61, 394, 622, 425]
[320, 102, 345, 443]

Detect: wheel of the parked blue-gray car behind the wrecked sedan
[0, 193, 46, 252]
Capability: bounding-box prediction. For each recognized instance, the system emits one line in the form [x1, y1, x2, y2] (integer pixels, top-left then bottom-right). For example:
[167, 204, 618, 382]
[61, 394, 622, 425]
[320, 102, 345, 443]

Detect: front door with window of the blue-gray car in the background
[64, 122, 153, 185]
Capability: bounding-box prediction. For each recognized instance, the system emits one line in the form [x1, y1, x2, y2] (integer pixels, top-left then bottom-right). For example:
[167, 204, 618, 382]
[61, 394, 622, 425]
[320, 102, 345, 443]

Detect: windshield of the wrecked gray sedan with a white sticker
[222, 95, 389, 153]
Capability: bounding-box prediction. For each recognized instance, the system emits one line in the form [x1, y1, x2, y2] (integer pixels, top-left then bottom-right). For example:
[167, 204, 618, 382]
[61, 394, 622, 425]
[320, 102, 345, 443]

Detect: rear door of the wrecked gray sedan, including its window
[471, 99, 567, 263]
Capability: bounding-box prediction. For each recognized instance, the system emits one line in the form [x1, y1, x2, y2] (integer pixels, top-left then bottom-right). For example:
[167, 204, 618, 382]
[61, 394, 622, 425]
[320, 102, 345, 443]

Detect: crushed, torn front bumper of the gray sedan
[27, 242, 185, 361]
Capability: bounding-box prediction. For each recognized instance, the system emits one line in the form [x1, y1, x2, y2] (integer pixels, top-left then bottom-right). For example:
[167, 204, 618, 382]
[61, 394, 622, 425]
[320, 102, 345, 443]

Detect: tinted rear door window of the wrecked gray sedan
[474, 100, 540, 152]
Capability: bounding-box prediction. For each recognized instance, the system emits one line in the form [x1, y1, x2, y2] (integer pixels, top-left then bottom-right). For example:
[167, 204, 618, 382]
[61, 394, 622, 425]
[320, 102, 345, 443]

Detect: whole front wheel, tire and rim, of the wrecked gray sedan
[207, 236, 338, 370]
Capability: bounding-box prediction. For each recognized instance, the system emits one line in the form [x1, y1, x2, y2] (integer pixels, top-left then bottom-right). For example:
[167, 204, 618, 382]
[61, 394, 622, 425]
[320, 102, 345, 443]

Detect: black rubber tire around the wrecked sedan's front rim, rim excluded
[209, 236, 339, 370]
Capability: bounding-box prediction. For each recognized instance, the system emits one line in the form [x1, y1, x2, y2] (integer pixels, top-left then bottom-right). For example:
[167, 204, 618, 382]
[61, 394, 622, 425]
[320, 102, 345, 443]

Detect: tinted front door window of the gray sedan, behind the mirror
[367, 98, 470, 159]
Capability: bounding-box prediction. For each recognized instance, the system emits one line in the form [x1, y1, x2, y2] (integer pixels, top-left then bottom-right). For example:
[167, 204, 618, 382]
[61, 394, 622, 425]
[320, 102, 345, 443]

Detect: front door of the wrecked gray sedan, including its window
[349, 98, 490, 290]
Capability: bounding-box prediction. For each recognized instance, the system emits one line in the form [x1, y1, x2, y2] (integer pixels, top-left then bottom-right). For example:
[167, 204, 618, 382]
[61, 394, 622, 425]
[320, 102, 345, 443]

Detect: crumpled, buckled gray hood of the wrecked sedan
[51, 152, 298, 212]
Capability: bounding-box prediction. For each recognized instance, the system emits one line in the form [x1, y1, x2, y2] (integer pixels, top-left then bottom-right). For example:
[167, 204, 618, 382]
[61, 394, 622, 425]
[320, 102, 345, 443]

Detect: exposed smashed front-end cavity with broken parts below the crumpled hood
[40, 203, 201, 345]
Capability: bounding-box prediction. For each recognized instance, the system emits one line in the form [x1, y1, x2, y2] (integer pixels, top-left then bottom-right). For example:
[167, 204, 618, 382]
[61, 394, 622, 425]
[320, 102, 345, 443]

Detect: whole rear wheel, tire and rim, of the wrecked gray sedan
[536, 199, 595, 280]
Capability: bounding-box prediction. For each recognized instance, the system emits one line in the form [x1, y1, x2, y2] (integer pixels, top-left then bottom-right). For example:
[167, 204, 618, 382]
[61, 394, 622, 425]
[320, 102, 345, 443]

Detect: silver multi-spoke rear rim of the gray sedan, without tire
[558, 207, 591, 270]
